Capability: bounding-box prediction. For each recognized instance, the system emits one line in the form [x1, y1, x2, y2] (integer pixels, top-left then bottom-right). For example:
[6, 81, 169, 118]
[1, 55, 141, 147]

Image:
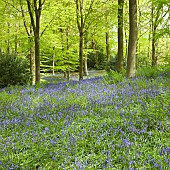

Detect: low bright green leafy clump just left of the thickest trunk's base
[103, 70, 124, 84]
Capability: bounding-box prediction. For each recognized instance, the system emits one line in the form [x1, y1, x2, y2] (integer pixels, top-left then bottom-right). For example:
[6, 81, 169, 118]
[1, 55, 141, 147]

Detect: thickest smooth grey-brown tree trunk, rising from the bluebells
[126, 0, 137, 78]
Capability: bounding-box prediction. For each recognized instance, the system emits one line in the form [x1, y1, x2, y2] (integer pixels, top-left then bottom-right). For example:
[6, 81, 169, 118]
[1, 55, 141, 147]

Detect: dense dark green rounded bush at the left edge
[0, 54, 29, 88]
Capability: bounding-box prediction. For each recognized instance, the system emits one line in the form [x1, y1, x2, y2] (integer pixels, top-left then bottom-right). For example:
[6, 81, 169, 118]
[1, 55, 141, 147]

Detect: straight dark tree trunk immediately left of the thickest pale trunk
[117, 0, 124, 72]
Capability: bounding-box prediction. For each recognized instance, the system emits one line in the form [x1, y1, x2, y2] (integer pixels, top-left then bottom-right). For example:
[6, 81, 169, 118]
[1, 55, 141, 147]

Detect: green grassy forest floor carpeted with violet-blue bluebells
[0, 69, 170, 170]
